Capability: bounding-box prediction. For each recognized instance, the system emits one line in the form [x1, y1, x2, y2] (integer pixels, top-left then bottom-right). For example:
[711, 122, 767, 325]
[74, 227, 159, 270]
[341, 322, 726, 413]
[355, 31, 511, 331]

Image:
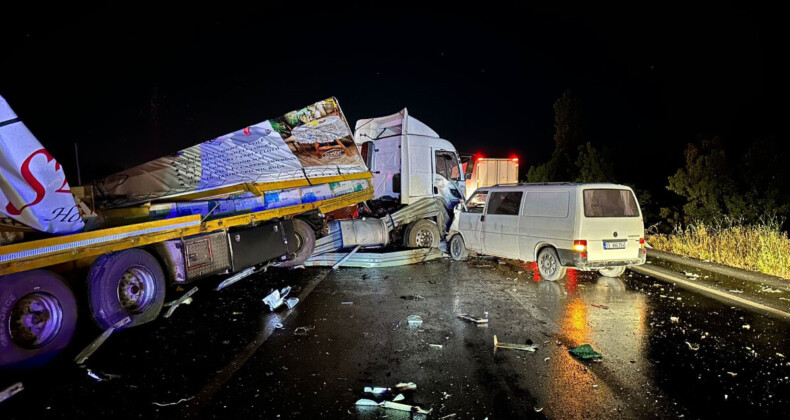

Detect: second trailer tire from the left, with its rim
[88, 249, 165, 329]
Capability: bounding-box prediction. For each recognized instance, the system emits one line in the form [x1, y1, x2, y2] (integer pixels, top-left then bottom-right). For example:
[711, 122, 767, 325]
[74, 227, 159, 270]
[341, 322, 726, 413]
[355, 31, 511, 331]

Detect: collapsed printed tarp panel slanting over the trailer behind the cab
[96, 98, 367, 207]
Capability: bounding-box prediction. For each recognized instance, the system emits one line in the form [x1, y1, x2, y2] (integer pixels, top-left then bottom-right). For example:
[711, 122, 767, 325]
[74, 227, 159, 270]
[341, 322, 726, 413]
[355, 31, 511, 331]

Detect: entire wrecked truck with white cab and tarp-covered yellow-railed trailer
[0, 98, 464, 367]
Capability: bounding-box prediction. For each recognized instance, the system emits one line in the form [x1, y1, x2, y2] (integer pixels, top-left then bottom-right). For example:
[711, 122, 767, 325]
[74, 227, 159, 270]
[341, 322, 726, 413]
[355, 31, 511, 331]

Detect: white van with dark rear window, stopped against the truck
[449, 183, 646, 280]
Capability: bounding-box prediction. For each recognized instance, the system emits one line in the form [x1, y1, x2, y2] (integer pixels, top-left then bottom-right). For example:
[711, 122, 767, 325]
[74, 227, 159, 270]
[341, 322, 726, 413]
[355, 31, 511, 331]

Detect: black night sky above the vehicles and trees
[0, 2, 787, 199]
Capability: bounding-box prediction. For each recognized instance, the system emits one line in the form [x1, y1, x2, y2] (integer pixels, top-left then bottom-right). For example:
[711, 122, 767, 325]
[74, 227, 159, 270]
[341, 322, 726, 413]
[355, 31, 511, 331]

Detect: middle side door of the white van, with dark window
[483, 190, 524, 259]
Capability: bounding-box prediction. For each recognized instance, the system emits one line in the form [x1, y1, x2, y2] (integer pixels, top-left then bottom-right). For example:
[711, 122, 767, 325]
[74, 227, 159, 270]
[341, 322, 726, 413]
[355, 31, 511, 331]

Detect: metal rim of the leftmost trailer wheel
[8, 293, 63, 350]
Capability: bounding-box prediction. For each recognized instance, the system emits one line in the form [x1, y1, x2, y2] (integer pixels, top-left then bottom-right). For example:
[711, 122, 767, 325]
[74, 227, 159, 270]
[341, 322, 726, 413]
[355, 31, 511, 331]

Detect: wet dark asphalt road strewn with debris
[0, 259, 790, 420]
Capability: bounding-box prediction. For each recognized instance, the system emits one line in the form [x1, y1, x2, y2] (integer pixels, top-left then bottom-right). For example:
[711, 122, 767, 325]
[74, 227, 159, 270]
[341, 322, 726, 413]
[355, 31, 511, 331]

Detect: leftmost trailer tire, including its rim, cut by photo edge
[0, 270, 77, 367]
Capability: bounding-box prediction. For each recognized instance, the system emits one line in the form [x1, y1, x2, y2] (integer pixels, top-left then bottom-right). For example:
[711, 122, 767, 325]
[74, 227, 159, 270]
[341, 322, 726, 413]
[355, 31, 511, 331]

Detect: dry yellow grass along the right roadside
[647, 218, 790, 280]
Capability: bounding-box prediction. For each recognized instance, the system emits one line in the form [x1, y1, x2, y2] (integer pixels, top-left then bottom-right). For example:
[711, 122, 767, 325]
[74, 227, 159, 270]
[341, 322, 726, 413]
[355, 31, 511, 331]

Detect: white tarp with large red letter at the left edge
[0, 96, 84, 233]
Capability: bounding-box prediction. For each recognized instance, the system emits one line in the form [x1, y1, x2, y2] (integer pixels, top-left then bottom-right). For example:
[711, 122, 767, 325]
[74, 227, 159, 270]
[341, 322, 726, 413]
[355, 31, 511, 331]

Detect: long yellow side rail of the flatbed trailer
[0, 185, 373, 276]
